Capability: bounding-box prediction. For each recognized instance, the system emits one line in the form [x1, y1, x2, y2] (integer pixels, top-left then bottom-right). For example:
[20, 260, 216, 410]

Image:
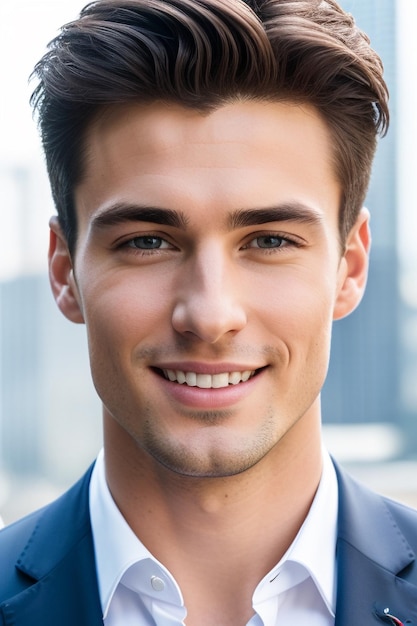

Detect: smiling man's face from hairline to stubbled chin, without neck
[52, 102, 368, 476]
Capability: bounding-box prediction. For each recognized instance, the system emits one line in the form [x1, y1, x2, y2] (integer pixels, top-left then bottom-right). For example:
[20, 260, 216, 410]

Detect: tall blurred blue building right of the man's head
[323, 0, 416, 450]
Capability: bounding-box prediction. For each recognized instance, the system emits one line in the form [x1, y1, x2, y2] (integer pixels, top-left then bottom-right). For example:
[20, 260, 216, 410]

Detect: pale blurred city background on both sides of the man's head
[0, 0, 417, 523]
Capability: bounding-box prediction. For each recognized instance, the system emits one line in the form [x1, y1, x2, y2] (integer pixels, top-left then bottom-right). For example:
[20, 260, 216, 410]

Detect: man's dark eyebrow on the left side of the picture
[91, 203, 188, 230]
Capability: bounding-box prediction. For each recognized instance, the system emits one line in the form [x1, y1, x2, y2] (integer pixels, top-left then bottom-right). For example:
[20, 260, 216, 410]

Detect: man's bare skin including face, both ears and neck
[50, 101, 369, 625]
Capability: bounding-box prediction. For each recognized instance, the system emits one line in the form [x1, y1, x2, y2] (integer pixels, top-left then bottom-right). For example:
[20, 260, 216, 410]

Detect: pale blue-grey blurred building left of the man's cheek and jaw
[0, 274, 101, 483]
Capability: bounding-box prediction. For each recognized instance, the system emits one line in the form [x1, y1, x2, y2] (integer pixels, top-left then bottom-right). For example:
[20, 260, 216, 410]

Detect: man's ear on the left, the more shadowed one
[48, 217, 84, 324]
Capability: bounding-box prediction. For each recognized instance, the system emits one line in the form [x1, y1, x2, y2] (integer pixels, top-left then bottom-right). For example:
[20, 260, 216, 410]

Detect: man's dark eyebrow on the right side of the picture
[228, 202, 323, 230]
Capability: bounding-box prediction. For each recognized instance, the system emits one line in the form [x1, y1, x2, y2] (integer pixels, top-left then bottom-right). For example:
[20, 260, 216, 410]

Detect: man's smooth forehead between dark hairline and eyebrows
[75, 101, 340, 236]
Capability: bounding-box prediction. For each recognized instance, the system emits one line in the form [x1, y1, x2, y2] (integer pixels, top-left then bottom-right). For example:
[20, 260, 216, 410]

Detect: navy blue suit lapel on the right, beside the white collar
[335, 466, 417, 626]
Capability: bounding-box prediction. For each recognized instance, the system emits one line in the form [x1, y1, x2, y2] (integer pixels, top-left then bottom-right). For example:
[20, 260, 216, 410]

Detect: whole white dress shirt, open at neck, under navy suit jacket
[90, 451, 338, 626]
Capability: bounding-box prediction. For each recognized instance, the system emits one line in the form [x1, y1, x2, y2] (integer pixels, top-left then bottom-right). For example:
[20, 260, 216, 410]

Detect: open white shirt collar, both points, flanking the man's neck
[90, 451, 338, 617]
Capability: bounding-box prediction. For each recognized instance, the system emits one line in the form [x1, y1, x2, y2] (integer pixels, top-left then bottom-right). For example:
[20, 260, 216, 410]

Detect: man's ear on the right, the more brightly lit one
[333, 208, 371, 320]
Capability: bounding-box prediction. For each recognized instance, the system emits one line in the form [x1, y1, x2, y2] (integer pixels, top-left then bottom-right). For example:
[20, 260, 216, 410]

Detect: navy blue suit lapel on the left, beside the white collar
[3, 470, 103, 626]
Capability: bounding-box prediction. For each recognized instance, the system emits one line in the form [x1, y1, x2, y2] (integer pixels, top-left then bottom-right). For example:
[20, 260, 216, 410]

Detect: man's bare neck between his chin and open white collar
[101, 416, 322, 624]
